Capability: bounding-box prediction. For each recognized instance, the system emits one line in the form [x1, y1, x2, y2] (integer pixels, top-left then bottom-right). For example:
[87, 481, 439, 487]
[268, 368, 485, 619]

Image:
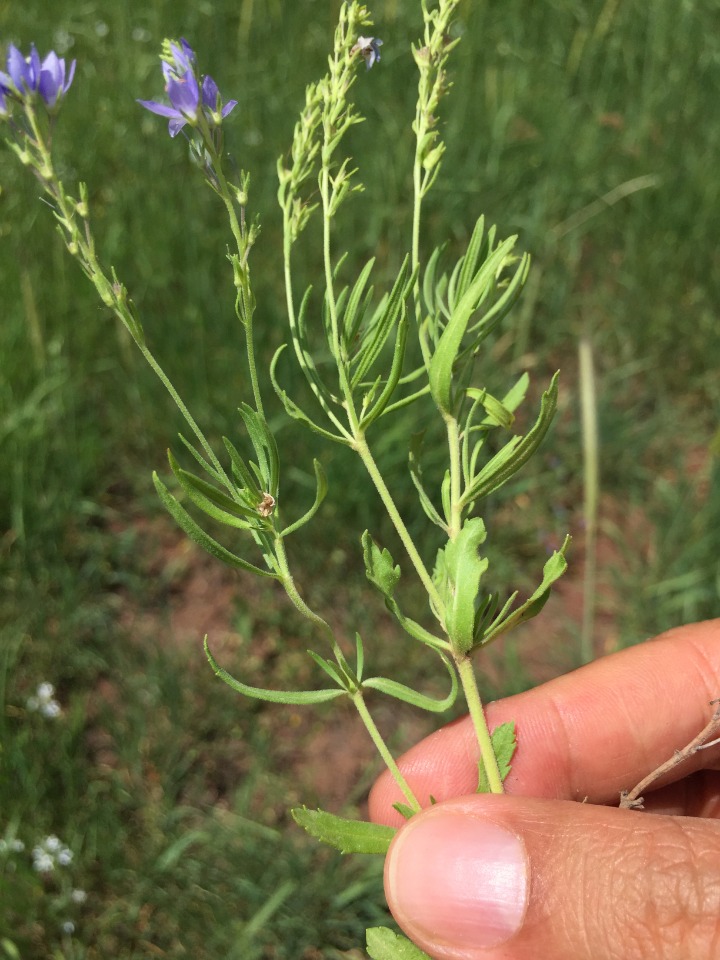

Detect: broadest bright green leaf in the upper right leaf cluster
[428, 237, 517, 414]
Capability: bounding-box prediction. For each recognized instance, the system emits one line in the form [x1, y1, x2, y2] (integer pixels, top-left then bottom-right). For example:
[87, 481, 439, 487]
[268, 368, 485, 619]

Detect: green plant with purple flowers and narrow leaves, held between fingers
[0, 0, 567, 958]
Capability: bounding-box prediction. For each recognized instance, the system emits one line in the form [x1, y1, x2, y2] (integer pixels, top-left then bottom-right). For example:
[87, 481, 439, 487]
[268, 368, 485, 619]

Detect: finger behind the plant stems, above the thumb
[370, 619, 720, 825]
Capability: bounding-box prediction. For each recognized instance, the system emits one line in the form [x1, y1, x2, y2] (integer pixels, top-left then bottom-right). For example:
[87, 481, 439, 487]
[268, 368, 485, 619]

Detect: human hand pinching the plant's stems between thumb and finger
[370, 620, 720, 960]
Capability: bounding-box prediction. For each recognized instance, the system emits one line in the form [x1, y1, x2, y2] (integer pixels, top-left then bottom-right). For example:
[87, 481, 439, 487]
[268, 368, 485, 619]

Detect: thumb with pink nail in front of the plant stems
[385, 794, 720, 960]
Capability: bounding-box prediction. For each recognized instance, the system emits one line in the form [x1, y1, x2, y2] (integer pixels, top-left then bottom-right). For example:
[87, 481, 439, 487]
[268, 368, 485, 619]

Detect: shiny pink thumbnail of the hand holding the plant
[385, 810, 529, 949]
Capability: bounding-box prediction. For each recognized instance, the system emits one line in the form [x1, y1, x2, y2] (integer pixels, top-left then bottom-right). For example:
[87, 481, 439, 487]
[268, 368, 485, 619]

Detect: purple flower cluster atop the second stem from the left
[138, 39, 237, 137]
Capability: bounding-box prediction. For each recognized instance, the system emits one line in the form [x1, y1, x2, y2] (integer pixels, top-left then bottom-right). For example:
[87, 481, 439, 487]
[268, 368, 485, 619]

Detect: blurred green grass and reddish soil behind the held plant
[0, 0, 720, 960]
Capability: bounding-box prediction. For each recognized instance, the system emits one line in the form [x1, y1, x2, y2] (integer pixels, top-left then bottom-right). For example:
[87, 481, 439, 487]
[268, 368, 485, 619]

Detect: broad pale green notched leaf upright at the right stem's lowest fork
[438, 517, 488, 654]
